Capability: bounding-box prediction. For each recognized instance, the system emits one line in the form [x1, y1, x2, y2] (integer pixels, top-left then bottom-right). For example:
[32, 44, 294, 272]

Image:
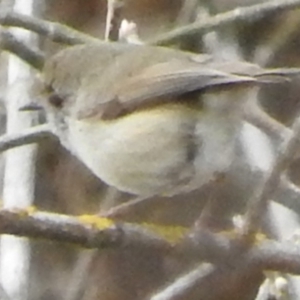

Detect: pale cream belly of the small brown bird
[68, 104, 238, 196]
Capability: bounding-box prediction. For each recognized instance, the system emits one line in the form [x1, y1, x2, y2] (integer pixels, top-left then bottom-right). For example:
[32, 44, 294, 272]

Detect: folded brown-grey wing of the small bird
[78, 60, 257, 119]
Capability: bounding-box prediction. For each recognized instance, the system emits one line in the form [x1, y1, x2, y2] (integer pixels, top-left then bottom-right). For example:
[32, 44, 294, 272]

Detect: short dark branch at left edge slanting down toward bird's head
[0, 30, 45, 70]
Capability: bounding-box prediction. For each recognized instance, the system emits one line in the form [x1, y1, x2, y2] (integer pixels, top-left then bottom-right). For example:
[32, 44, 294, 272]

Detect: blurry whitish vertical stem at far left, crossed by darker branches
[0, 0, 40, 300]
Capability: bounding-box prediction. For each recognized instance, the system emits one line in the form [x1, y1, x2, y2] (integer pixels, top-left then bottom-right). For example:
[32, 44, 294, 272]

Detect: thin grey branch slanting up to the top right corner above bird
[149, 0, 300, 45]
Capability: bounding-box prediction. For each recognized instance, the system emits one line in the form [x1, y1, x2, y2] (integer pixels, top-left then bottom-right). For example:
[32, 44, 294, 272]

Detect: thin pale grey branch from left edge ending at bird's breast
[0, 124, 55, 153]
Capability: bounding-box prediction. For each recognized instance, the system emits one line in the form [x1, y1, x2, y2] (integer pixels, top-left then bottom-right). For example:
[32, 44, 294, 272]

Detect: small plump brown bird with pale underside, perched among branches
[39, 42, 299, 197]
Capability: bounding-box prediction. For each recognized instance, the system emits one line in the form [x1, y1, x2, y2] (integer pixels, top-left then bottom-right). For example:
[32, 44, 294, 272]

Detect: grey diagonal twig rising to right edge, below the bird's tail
[241, 106, 300, 239]
